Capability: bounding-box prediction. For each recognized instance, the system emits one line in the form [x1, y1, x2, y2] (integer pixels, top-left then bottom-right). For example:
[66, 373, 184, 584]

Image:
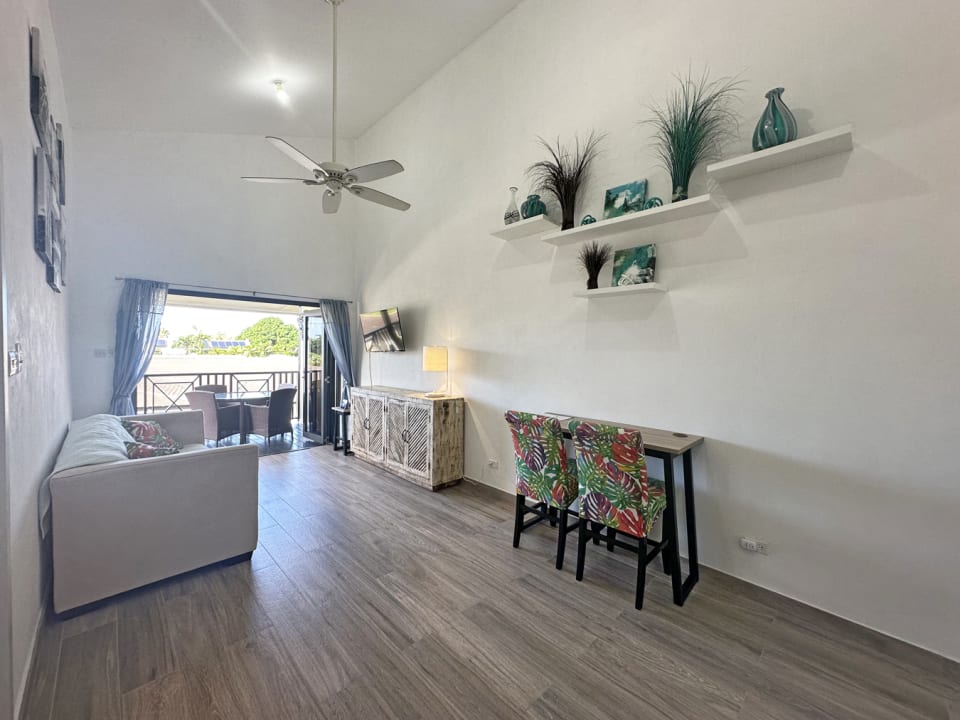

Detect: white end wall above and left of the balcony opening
[70, 130, 354, 417]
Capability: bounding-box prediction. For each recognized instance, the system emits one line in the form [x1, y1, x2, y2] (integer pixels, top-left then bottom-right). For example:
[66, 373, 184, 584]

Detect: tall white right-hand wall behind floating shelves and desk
[357, 0, 960, 659]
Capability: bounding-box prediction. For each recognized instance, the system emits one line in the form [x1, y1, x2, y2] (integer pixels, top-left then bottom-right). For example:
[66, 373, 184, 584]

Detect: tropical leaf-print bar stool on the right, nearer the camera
[569, 420, 677, 610]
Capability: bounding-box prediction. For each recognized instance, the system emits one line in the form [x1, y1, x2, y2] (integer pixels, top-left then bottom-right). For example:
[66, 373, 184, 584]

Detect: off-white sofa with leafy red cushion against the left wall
[49, 411, 259, 613]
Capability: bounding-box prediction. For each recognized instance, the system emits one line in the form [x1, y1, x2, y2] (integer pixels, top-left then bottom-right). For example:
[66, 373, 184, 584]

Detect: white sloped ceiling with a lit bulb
[50, 0, 519, 137]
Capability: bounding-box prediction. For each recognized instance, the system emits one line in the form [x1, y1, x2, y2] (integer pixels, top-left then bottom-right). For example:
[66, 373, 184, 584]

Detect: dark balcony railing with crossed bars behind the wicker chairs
[133, 370, 323, 417]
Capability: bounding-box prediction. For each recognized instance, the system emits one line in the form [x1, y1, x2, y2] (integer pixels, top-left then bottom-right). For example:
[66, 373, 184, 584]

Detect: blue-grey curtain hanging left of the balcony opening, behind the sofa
[110, 279, 167, 415]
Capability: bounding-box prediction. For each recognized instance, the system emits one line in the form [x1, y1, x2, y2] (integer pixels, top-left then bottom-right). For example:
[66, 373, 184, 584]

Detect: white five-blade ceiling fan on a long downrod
[243, 0, 410, 213]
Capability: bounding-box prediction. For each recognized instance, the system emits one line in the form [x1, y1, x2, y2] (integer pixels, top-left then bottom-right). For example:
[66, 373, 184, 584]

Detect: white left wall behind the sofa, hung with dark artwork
[0, 0, 76, 717]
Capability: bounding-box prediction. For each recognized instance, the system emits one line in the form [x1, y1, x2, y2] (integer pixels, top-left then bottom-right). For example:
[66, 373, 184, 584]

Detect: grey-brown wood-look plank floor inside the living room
[16, 448, 960, 720]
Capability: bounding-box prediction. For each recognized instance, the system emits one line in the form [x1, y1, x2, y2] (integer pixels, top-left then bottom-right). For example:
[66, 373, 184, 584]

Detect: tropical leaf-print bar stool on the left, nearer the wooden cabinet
[504, 410, 581, 570]
